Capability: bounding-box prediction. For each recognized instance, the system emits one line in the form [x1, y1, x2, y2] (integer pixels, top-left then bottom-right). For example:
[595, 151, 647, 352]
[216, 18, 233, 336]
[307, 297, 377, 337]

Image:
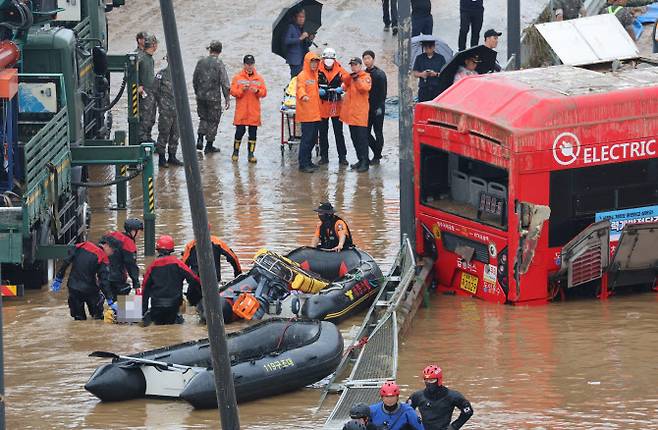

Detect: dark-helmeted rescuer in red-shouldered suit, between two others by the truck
[106, 218, 144, 301]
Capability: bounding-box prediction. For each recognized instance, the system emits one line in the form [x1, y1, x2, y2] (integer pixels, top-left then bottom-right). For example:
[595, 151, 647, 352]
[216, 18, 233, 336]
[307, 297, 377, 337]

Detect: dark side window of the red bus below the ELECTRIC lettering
[548, 159, 658, 247]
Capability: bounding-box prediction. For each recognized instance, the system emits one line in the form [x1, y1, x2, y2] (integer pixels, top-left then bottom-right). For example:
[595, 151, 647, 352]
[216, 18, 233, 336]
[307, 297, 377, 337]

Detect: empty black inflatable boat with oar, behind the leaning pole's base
[85, 318, 343, 408]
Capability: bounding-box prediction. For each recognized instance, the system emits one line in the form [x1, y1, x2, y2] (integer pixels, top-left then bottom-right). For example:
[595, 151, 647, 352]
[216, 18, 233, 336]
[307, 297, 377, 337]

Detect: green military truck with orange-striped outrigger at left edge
[0, 0, 155, 295]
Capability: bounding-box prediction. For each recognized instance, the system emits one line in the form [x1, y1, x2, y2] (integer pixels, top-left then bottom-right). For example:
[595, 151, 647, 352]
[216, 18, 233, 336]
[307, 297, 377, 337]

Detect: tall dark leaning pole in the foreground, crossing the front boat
[160, 0, 240, 430]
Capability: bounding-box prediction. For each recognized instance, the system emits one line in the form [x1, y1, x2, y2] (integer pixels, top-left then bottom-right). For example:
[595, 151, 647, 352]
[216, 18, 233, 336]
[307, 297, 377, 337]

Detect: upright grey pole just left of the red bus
[398, 0, 412, 244]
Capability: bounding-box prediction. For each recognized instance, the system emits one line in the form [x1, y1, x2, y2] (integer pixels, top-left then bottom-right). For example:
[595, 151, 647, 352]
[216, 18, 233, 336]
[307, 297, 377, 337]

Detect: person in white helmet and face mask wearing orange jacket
[318, 48, 349, 166]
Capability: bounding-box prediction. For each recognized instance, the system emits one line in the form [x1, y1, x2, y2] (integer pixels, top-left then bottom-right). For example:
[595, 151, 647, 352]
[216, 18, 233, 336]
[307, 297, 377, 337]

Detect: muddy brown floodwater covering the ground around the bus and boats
[4, 0, 658, 429]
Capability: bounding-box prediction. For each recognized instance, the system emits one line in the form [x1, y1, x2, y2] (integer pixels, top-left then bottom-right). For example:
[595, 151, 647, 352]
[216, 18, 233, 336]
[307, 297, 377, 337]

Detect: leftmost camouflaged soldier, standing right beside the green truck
[137, 34, 158, 142]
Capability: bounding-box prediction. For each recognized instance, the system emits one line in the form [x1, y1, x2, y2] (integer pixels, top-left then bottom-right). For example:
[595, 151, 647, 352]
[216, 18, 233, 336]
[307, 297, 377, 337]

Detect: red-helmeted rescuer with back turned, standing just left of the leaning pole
[142, 235, 201, 324]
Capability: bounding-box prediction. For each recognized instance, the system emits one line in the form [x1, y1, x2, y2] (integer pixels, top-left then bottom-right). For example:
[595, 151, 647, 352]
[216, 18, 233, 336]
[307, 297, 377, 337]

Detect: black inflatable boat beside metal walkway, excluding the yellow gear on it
[221, 247, 384, 323]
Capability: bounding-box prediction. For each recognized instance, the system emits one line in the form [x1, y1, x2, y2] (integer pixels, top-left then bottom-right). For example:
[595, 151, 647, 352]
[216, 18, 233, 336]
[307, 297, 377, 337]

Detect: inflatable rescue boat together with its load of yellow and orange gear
[221, 247, 383, 323]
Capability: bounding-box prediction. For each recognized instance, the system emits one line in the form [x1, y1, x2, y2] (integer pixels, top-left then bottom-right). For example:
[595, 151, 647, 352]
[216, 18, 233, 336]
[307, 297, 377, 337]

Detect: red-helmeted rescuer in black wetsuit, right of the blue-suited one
[408, 365, 473, 430]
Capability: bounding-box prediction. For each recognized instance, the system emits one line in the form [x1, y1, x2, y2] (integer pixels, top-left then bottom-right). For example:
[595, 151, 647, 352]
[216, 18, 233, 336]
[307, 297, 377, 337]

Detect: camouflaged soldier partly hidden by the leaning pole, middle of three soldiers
[153, 66, 183, 167]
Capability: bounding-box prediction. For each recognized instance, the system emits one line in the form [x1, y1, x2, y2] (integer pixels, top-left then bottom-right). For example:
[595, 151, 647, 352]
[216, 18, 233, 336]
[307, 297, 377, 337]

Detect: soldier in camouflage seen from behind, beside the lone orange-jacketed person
[192, 40, 231, 154]
